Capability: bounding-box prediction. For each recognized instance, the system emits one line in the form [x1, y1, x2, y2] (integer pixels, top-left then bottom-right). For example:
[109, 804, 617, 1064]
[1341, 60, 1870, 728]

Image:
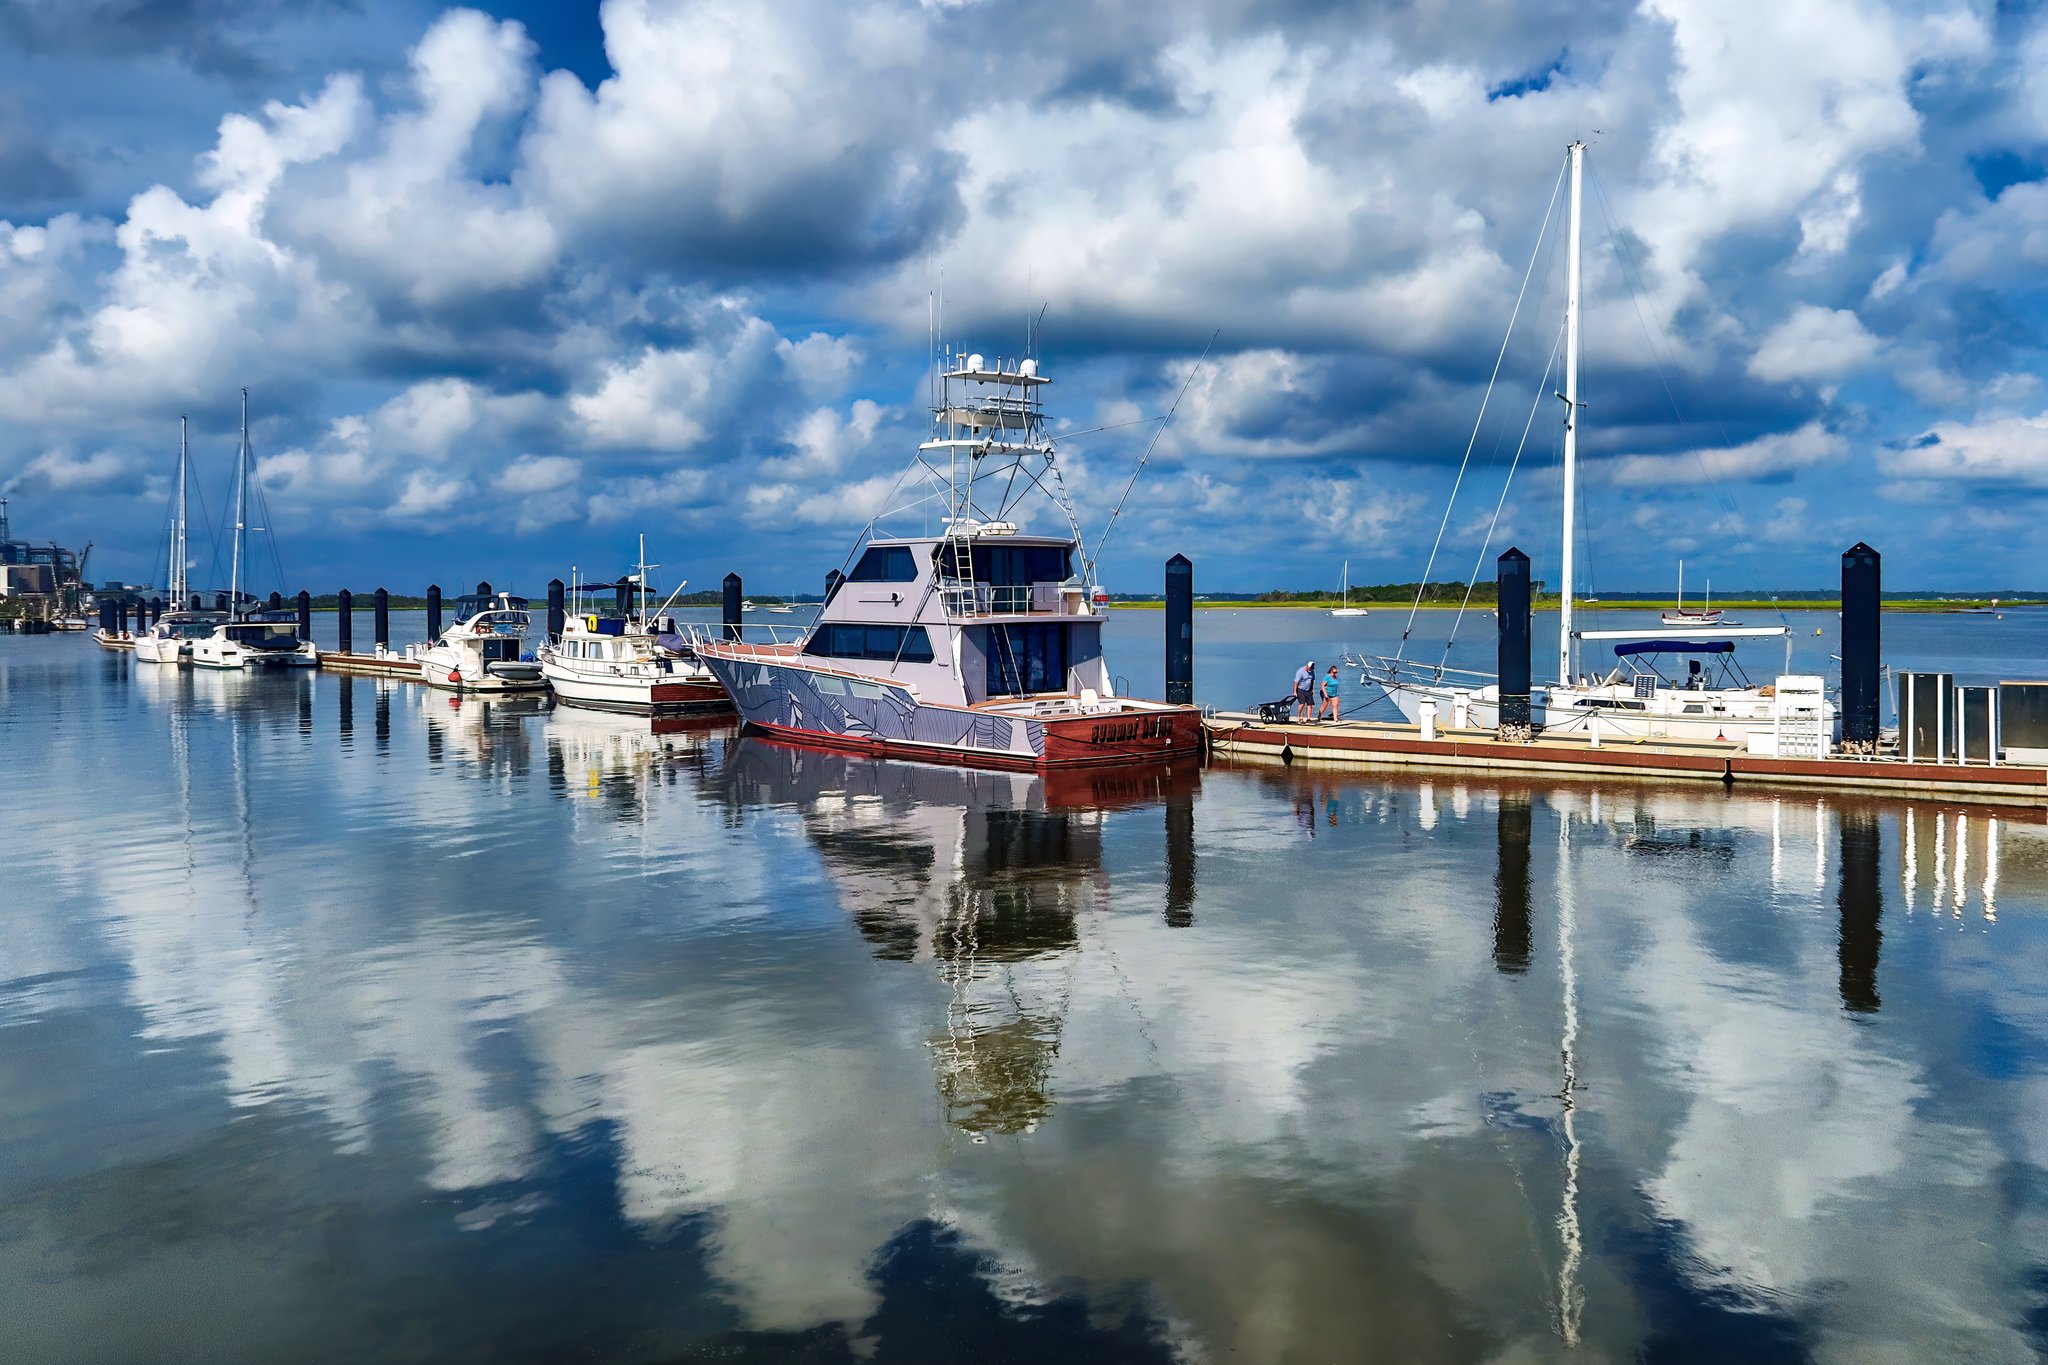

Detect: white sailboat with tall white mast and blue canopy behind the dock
[1346, 143, 1839, 743]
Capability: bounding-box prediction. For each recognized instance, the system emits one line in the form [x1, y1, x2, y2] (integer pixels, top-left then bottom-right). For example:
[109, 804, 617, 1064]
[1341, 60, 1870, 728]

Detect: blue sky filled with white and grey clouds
[0, 0, 2048, 593]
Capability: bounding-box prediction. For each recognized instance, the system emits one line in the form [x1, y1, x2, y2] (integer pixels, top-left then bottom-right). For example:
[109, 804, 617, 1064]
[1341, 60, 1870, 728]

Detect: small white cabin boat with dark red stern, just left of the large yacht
[539, 536, 731, 716]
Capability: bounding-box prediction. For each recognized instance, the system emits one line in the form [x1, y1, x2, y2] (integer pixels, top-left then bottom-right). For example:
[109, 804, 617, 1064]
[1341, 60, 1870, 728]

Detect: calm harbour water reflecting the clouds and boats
[0, 612, 2048, 1361]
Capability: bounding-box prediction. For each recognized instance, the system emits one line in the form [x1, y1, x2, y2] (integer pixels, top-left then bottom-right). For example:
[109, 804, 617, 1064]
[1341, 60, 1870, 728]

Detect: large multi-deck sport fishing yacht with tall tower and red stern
[696, 350, 1202, 767]
